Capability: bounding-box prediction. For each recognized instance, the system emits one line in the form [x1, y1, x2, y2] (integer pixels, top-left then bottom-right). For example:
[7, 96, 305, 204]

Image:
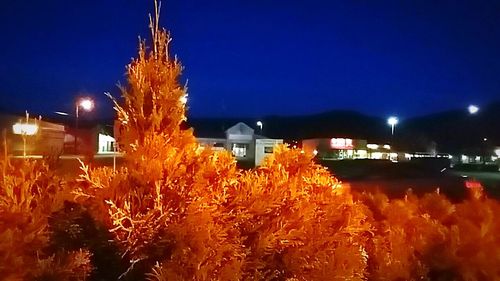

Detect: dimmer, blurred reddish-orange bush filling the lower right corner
[362, 190, 500, 280]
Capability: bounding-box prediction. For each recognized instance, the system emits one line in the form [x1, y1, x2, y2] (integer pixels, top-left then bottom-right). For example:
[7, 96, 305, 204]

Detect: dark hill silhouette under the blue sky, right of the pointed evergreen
[188, 102, 500, 153]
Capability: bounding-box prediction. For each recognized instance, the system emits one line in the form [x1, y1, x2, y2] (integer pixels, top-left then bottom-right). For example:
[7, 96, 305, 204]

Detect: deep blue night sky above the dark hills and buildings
[0, 0, 500, 117]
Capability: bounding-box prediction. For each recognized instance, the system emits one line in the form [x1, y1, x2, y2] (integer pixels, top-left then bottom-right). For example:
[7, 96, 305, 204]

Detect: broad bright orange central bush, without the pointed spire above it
[79, 136, 370, 280]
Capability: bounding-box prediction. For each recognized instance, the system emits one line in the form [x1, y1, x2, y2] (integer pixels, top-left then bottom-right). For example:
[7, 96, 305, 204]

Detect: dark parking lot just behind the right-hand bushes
[320, 160, 500, 200]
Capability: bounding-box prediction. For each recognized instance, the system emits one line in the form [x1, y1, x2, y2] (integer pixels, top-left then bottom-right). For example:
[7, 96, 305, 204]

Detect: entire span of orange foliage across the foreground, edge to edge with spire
[0, 1, 500, 280]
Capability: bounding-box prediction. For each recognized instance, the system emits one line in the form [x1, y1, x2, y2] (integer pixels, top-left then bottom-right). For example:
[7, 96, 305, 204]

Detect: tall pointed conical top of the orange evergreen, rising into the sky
[115, 1, 187, 151]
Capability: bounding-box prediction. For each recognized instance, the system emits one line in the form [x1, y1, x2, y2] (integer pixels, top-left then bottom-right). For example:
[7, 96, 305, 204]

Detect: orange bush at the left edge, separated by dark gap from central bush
[0, 159, 91, 280]
